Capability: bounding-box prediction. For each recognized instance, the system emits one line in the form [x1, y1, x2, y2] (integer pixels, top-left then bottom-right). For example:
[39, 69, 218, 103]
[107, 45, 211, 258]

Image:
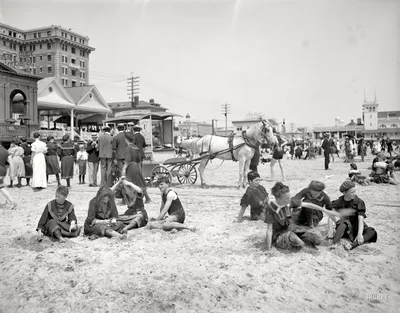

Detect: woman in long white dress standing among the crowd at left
[31, 133, 47, 190]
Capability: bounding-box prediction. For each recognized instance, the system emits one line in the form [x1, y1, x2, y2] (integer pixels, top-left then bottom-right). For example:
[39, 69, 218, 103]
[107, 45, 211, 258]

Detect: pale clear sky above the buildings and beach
[0, 0, 400, 126]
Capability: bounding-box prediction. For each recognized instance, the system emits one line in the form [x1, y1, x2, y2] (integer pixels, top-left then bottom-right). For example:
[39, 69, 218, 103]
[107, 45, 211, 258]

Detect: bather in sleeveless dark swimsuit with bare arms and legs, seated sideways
[149, 177, 196, 231]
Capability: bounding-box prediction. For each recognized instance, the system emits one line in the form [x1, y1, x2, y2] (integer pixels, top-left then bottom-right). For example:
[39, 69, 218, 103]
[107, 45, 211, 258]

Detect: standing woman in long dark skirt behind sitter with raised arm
[121, 132, 151, 203]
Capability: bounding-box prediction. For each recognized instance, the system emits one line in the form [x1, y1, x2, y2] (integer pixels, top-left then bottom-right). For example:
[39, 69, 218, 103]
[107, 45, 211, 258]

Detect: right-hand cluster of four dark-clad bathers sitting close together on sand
[238, 172, 377, 250]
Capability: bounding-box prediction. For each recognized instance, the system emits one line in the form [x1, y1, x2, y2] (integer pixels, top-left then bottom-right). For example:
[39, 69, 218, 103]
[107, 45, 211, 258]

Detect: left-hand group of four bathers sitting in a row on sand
[36, 177, 196, 242]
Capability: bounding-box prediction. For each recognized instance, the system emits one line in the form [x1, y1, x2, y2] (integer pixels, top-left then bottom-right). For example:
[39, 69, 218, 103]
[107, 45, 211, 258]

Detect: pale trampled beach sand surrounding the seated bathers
[0, 157, 400, 313]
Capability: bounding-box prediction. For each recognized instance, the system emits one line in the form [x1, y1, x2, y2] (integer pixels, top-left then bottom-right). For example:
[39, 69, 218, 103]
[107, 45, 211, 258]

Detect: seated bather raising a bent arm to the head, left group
[111, 177, 148, 232]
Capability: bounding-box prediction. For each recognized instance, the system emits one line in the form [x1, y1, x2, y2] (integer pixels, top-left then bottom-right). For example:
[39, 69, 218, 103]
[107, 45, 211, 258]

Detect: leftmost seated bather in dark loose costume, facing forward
[36, 186, 82, 242]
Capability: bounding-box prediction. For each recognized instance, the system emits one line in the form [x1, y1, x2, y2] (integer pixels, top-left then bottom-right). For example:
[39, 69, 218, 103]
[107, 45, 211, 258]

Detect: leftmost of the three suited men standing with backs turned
[98, 126, 113, 185]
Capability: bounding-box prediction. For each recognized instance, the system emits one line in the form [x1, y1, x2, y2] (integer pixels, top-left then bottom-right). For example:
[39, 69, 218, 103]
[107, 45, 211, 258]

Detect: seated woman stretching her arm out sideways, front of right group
[265, 182, 339, 250]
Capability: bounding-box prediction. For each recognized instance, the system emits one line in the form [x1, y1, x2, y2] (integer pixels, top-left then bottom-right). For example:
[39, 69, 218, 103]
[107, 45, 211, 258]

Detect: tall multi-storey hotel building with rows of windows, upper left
[0, 23, 95, 87]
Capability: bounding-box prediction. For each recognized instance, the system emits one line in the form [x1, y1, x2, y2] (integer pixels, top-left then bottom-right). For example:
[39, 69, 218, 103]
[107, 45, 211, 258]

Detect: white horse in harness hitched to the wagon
[182, 120, 276, 188]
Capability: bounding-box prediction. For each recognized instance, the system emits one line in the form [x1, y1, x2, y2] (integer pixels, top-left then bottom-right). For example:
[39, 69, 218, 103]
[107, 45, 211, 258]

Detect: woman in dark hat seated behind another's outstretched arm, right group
[292, 180, 332, 227]
